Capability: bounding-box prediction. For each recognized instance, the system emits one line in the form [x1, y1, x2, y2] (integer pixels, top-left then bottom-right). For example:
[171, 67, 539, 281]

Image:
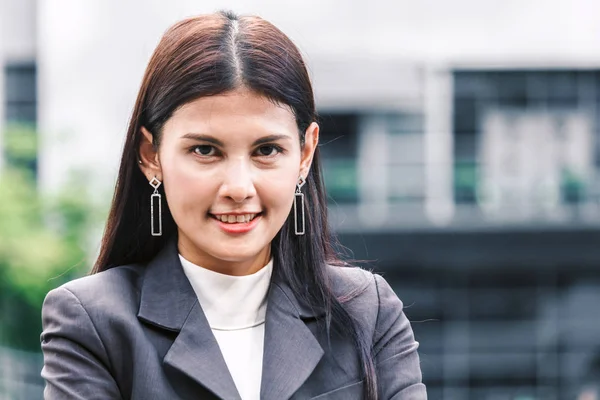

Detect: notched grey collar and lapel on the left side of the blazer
[138, 239, 241, 399]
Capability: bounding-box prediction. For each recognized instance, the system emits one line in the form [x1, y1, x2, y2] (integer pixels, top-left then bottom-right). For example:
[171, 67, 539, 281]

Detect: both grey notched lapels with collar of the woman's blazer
[138, 237, 324, 400]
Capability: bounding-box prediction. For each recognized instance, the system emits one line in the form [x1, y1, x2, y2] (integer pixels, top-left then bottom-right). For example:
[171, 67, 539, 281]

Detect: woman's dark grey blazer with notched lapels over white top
[41, 243, 427, 400]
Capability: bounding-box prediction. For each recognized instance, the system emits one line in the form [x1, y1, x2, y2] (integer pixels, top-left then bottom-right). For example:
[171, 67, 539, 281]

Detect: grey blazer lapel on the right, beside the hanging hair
[260, 278, 324, 400]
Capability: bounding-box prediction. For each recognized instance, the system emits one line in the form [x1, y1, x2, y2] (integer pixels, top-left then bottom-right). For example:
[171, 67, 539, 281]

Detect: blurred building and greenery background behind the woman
[0, 0, 600, 400]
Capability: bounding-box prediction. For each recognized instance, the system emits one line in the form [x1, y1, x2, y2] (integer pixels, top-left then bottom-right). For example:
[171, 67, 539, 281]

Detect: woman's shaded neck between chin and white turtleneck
[177, 236, 271, 276]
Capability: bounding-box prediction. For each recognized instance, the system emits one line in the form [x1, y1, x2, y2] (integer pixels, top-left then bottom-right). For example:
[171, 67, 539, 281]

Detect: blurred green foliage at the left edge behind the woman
[0, 126, 105, 350]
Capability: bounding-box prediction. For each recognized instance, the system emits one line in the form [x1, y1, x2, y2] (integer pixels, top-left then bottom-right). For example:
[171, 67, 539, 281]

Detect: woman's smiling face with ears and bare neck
[140, 89, 319, 275]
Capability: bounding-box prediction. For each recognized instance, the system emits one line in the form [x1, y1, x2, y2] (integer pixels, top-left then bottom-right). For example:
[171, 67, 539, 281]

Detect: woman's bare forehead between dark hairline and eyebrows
[164, 89, 297, 137]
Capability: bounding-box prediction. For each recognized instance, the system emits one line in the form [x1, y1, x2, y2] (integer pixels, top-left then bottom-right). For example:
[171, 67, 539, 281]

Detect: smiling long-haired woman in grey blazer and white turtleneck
[42, 13, 426, 400]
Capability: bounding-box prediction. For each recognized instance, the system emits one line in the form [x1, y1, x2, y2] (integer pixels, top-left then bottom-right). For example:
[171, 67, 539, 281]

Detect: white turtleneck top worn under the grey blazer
[179, 254, 273, 400]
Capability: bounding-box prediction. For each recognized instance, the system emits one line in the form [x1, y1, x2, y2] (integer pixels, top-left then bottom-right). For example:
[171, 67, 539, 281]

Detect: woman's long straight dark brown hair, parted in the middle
[92, 12, 377, 399]
